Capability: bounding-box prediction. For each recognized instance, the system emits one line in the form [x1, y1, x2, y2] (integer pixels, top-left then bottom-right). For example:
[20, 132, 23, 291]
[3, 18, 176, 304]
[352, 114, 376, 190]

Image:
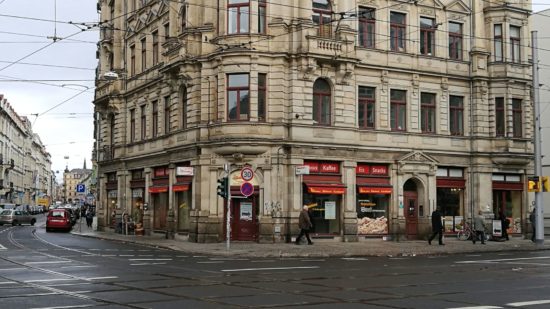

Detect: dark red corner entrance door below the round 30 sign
[224, 196, 259, 241]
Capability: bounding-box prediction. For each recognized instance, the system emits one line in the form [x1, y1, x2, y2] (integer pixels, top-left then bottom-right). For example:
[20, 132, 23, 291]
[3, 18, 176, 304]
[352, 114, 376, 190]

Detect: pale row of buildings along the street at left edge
[0, 95, 55, 205]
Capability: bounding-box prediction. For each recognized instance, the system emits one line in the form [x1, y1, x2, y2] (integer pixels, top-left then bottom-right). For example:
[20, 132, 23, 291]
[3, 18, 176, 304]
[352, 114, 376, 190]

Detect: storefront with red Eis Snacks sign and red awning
[355, 163, 392, 236]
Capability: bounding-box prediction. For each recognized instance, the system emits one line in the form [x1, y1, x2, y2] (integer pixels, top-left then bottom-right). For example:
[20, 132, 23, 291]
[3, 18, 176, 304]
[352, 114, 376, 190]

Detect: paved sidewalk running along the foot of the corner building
[71, 223, 550, 258]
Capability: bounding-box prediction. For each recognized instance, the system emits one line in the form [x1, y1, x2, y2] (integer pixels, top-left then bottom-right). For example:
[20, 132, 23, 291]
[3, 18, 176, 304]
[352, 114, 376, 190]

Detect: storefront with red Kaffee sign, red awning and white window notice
[302, 161, 346, 236]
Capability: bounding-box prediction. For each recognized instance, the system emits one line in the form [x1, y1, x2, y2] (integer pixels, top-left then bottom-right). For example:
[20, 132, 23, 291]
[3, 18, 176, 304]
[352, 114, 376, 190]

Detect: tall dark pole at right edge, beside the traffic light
[531, 31, 544, 246]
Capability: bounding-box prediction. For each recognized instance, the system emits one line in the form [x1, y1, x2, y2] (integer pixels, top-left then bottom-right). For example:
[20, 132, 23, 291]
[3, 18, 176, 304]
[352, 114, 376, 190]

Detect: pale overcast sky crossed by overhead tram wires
[0, 0, 550, 179]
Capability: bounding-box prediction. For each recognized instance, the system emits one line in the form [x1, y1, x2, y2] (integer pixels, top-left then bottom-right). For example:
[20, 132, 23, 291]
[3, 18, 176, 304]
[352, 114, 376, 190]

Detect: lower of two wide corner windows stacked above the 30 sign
[227, 74, 250, 121]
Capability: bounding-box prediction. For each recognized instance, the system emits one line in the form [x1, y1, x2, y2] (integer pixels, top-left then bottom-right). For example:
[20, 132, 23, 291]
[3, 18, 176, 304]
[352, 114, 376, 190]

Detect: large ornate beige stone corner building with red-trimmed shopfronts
[94, 0, 534, 242]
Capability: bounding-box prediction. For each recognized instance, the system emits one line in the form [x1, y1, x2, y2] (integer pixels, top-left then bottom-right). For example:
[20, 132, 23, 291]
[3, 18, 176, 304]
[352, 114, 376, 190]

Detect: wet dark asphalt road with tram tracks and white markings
[0, 218, 550, 309]
